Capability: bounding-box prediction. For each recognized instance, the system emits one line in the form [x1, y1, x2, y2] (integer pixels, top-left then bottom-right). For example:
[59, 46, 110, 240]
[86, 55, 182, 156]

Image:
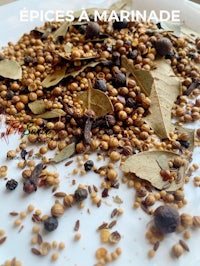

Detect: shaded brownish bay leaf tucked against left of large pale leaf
[121, 56, 154, 96]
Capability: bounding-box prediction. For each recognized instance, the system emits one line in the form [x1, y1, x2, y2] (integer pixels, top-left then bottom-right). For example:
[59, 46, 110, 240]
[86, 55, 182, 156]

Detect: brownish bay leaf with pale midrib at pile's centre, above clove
[77, 88, 114, 118]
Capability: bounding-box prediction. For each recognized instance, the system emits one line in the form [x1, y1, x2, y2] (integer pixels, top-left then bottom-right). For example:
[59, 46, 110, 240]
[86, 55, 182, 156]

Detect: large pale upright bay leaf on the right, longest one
[145, 59, 180, 139]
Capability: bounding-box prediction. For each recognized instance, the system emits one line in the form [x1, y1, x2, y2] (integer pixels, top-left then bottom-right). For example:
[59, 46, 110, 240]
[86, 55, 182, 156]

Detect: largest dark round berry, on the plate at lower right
[154, 205, 180, 233]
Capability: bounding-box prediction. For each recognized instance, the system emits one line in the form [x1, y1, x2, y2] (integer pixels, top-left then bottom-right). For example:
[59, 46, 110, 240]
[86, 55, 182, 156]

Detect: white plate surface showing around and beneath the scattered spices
[0, 0, 200, 266]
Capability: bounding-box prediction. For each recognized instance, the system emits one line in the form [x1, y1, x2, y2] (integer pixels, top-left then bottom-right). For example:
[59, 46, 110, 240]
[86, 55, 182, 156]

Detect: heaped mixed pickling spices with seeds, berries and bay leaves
[0, 1, 200, 265]
